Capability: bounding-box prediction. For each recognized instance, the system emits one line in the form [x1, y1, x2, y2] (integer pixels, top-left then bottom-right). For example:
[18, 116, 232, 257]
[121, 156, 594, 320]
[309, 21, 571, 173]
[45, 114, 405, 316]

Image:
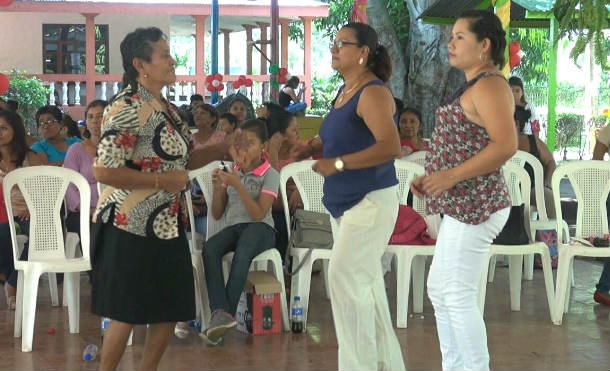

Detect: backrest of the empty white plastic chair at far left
[3, 166, 91, 266]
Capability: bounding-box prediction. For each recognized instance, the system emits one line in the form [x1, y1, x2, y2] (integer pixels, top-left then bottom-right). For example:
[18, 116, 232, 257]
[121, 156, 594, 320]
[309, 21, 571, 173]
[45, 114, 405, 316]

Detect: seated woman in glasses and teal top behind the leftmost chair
[30, 106, 81, 166]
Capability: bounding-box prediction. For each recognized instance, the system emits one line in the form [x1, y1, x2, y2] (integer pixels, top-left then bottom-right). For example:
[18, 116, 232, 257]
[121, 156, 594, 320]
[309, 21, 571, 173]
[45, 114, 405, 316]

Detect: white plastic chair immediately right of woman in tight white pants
[479, 161, 555, 319]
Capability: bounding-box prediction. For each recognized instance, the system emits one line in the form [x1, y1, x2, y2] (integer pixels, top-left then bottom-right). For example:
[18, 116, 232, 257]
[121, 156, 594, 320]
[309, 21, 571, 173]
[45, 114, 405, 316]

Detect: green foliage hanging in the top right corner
[553, 0, 610, 69]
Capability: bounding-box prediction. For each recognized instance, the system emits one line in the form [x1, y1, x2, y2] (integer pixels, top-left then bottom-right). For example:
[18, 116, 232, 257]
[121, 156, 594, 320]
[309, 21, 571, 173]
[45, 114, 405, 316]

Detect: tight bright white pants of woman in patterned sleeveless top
[428, 208, 510, 371]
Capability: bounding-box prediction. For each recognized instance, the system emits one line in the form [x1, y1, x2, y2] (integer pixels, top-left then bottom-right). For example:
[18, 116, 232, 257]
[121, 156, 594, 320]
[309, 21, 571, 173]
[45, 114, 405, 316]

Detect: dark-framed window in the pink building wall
[42, 24, 108, 74]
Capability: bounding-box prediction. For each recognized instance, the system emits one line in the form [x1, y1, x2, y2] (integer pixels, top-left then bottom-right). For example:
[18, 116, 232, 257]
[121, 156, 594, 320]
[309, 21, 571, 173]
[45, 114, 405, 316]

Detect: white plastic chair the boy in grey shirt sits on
[187, 161, 290, 331]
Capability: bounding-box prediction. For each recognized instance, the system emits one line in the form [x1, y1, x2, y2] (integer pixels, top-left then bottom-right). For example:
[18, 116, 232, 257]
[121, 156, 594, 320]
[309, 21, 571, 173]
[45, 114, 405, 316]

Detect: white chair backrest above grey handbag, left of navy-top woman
[280, 160, 329, 238]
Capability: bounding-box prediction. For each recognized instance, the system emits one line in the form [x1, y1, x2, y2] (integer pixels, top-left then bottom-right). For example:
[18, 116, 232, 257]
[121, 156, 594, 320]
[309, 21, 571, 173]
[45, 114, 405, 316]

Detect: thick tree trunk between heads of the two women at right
[405, 0, 465, 137]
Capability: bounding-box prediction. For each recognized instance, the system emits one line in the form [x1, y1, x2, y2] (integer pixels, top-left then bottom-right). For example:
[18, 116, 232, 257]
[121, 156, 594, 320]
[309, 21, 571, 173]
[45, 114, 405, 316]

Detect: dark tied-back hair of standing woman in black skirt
[121, 27, 166, 92]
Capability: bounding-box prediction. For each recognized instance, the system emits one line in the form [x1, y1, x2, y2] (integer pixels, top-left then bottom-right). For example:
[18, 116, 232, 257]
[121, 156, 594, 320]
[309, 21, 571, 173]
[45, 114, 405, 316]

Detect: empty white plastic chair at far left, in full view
[3, 166, 91, 352]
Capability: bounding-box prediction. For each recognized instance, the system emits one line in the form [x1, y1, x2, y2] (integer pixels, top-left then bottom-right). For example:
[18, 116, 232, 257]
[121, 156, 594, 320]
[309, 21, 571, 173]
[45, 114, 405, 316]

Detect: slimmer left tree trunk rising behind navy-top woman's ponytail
[366, 0, 407, 100]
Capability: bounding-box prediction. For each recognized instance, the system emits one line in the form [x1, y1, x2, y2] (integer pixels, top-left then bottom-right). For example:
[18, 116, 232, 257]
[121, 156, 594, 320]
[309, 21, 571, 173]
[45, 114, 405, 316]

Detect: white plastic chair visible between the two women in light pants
[386, 160, 440, 328]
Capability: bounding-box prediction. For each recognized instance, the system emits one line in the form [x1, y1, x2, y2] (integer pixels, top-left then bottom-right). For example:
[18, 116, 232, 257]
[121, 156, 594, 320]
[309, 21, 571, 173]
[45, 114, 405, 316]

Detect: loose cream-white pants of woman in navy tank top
[328, 187, 405, 370]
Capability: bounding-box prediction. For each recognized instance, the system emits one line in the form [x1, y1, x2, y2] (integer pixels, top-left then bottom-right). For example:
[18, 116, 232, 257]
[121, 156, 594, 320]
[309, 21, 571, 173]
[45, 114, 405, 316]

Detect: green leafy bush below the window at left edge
[2, 69, 49, 133]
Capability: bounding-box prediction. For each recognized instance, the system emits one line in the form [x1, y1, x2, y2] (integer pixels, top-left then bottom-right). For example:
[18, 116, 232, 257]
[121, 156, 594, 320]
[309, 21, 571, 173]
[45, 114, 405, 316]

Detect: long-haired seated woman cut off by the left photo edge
[0, 111, 46, 310]
